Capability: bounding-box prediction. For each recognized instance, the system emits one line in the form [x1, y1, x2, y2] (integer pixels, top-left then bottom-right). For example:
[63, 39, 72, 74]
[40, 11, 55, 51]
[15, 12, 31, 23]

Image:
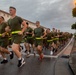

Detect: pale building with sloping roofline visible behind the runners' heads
[0, 10, 47, 30]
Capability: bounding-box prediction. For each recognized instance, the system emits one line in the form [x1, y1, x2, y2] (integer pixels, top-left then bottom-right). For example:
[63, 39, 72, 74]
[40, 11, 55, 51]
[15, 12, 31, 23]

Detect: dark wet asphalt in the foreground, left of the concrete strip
[0, 56, 55, 75]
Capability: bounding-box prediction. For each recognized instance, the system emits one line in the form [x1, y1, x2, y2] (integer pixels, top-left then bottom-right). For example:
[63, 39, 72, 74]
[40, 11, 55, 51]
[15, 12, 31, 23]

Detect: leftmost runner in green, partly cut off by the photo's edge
[0, 16, 13, 64]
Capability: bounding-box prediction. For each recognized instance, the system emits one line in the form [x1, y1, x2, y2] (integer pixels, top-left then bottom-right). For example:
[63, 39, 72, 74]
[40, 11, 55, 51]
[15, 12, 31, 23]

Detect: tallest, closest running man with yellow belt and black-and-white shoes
[7, 7, 27, 67]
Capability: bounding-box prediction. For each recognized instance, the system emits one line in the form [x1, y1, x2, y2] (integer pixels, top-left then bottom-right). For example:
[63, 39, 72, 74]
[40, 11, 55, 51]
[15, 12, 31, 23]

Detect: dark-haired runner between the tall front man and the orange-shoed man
[25, 22, 34, 57]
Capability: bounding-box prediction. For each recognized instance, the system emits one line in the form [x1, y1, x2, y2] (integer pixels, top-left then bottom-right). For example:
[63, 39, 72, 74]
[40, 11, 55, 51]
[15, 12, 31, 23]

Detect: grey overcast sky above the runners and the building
[0, 0, 76, 32]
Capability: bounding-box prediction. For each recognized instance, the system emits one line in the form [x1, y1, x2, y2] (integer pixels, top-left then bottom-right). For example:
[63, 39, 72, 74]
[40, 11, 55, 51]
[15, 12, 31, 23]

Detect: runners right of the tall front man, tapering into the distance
[24, 21, 72, 57]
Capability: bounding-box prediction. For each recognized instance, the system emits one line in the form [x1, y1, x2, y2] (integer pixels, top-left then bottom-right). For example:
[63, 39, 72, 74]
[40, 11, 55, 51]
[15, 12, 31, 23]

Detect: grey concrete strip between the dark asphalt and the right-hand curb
[54, 58, 73, 75]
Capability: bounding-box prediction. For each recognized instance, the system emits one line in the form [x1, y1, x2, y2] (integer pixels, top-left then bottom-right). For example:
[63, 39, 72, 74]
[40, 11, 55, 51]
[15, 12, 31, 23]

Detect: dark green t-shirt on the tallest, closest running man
[7, 16, 23, 32]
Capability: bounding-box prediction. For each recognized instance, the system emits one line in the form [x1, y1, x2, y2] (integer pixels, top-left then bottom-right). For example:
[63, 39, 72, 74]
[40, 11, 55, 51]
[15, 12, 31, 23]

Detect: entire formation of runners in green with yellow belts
[0, 7, 72, 67]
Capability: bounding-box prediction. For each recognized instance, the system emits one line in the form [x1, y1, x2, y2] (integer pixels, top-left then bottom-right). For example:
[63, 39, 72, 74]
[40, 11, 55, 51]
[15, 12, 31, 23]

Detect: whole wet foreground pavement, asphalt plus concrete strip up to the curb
[0, 56, 73, 75]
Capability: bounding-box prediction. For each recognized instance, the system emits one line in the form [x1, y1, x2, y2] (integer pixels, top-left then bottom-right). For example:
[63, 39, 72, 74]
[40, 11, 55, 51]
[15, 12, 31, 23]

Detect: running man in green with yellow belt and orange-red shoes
[34, 21, 45, 60]
